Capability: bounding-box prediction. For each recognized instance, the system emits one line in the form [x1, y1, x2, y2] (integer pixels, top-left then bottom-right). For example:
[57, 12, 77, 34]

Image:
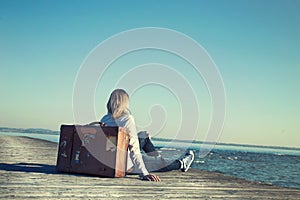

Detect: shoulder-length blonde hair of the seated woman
[106, 89, 129, 119]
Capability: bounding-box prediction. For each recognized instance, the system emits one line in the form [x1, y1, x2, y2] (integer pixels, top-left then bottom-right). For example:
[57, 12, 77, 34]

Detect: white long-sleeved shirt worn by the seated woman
[101, 113, 149, 176]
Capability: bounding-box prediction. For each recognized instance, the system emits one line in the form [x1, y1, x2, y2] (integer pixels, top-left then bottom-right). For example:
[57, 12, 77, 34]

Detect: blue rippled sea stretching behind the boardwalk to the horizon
[0, 132, 300, 189]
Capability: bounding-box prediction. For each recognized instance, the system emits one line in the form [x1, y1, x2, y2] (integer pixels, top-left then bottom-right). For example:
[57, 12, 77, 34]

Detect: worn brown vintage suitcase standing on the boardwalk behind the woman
[56, 125, 129, 178]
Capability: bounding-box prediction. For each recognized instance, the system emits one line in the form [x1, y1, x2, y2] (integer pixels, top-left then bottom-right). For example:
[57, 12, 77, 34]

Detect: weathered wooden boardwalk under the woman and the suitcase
[0, 136, 300, 199]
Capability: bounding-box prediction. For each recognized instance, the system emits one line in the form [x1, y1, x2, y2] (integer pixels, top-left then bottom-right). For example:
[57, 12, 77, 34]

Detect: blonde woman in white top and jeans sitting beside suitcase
[101, 89, 194, 181]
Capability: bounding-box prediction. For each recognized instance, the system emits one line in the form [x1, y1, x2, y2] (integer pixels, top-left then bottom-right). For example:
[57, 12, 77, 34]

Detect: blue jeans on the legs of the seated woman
[138, 132, 181, 172]
